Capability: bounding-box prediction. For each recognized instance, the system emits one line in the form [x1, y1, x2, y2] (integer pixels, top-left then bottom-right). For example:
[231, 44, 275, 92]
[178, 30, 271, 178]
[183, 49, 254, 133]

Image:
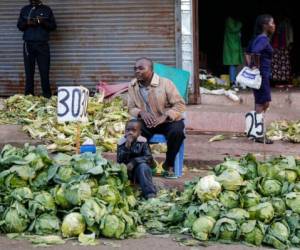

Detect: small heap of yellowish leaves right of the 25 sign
[267, 120, 300, 143]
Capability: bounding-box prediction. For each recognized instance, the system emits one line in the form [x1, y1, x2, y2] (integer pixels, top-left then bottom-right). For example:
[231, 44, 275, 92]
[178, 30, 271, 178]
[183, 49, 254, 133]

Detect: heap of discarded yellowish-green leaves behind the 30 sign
[0, 95, 129, 152]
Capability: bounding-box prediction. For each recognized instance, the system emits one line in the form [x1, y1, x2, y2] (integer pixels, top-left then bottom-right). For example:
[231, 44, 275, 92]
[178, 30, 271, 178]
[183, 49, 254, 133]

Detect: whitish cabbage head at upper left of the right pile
[194, 175, 221, 202]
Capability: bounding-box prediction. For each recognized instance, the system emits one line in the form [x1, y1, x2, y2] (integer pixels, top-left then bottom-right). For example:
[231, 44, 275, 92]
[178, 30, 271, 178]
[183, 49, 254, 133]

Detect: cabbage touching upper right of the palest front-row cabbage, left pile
[80, 198, 107, 226]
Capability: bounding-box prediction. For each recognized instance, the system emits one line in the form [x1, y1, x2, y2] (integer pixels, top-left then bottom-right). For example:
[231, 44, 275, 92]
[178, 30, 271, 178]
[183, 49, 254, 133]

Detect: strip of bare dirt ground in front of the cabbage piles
[0, 235, 267, 250]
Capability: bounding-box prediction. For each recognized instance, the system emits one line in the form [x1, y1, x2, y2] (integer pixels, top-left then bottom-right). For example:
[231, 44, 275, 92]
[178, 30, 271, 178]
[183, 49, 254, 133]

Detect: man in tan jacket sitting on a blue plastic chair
[128, 58, 185, 178]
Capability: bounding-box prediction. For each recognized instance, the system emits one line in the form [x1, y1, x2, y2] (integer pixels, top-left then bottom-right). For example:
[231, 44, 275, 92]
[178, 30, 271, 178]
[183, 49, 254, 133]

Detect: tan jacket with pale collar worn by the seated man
[128, 73, 185, 121]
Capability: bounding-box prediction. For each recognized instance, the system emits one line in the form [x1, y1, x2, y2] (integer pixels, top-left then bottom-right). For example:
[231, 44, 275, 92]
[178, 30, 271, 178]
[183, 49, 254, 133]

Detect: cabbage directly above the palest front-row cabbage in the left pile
[64, 182, 92, 206]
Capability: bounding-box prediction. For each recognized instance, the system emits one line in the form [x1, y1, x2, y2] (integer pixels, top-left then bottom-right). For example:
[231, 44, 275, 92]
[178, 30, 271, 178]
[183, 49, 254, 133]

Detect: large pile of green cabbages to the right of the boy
[139, 155, 300, 249]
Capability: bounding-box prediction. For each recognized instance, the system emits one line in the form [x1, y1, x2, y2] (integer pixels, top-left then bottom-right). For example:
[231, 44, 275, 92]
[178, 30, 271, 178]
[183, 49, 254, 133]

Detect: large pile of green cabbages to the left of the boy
[0, 145, 140, 244]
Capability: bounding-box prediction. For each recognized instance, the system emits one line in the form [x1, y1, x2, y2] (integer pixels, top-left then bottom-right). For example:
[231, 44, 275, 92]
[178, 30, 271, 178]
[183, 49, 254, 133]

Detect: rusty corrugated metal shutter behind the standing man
[0, 0, 176, 96]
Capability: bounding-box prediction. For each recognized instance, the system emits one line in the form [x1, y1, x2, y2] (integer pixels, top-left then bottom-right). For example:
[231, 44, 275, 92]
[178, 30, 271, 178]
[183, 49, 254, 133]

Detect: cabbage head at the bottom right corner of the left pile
[100, 214, 125, 239]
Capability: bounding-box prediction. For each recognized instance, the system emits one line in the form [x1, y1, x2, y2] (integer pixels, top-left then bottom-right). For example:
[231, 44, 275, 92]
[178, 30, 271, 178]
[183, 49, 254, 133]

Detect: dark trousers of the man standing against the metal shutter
[23, 42, 51, 98]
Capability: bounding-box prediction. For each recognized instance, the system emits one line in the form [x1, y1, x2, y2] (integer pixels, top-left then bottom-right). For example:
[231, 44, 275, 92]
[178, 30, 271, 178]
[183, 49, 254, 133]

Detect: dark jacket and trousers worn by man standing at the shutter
[17, 4, 56, 98]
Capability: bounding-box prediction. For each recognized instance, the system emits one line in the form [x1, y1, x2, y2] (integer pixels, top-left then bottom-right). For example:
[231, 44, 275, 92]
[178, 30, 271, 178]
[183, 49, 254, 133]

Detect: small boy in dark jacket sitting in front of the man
[117, 120, 156, 199]
